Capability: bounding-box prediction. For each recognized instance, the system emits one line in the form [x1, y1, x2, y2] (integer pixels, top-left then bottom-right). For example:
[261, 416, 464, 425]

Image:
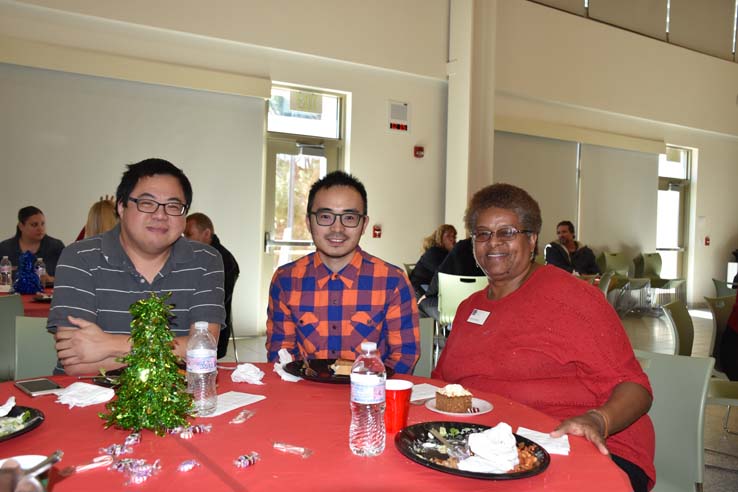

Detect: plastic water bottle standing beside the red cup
[349, 342, 387, 456]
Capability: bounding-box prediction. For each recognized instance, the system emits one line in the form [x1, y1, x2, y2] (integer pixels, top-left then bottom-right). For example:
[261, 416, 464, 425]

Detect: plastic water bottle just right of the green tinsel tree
[187, 321, 218, 415]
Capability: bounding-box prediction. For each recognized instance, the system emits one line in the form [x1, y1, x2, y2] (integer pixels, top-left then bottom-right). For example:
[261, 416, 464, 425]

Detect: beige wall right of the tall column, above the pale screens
[489, 0, 738, 302]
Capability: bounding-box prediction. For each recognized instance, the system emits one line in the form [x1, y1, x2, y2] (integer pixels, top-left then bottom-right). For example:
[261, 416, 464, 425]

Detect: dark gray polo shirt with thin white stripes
[47, 226, 225, 369]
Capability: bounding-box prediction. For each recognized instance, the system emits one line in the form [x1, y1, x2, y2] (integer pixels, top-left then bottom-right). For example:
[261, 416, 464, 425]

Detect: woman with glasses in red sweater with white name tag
[432, 183, 656, 492]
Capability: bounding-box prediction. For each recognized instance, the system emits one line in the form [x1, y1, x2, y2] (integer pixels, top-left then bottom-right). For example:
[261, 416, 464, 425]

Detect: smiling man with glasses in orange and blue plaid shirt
[266, 171, 420, 373]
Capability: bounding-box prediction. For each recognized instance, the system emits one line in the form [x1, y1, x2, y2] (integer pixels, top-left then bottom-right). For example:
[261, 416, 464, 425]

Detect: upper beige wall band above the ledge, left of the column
[12, 0, 449, 79]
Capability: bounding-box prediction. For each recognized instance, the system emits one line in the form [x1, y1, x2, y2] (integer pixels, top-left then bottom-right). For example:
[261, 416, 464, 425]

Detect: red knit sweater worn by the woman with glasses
[433, 266, 656, 488]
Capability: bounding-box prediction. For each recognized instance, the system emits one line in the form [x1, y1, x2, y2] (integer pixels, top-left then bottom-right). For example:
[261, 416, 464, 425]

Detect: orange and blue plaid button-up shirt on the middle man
[266, 247, 420, 373]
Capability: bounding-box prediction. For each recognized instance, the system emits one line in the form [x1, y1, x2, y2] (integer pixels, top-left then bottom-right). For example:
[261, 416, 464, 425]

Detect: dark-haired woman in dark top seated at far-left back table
[0, 206, 64, 284]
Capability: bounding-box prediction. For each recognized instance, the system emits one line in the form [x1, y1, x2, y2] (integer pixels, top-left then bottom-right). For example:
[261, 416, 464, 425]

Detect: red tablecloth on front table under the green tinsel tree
[0, 364, 630, 492]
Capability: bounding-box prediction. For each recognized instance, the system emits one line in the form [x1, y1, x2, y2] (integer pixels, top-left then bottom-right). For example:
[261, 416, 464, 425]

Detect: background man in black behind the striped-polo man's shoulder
[185, 212, 240, 359]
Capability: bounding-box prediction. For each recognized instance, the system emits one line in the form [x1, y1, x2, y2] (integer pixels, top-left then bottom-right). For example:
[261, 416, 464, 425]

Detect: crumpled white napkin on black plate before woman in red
[458, 422, 520, 473]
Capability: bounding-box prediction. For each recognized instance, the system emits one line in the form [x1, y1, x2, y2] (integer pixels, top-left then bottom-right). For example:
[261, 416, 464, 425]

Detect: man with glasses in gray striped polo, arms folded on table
[47, 159, 225, 375]
